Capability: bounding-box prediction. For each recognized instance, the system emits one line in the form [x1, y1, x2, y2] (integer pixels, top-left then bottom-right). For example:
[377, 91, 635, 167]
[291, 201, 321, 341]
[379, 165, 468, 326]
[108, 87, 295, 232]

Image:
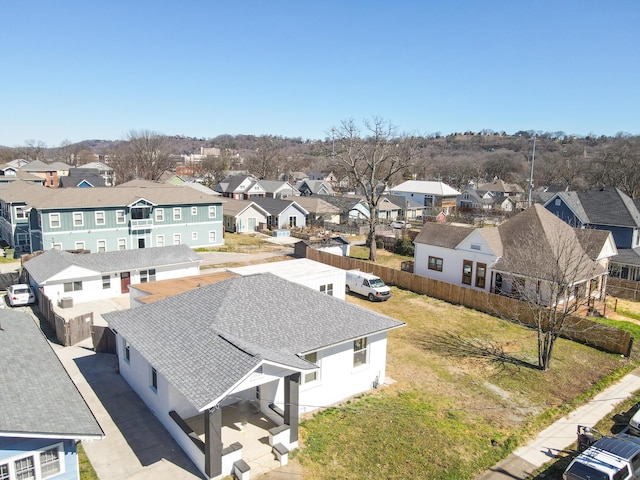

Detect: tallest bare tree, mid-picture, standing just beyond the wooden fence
[330, 118, 413, 261]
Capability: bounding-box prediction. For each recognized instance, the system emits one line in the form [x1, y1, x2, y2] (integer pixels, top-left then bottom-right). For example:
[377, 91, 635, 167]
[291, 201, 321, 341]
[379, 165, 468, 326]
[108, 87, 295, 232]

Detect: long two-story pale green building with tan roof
[0, 181, 224, 252]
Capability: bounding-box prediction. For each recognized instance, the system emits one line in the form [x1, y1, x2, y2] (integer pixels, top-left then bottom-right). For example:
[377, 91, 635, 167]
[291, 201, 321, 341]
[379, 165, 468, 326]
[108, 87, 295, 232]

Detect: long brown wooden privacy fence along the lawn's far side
[307, 248, 633, 356]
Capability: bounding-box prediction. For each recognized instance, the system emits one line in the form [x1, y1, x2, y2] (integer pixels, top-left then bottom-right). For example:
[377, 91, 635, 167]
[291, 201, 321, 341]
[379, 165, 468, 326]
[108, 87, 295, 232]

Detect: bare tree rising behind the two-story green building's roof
[122, 130, 173, 181]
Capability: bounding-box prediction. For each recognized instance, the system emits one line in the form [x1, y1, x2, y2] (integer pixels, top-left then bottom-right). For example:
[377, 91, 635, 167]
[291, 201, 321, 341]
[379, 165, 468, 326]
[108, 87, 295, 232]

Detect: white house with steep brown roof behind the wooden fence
[414, 205, 617, 304]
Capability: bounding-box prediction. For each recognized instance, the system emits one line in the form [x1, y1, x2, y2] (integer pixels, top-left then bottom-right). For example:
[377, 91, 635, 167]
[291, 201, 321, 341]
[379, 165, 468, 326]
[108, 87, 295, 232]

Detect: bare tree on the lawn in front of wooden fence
[493, 205, 606, 370]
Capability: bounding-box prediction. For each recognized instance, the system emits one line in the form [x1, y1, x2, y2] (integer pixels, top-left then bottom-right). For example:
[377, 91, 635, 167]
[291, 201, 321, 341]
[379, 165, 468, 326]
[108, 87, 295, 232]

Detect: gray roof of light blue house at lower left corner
[0, 309, 104, 439]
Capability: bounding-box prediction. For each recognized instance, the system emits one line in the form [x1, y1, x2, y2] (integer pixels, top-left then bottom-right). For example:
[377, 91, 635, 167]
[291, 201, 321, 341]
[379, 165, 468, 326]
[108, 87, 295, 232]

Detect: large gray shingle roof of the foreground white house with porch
[104, 273, 404, 409]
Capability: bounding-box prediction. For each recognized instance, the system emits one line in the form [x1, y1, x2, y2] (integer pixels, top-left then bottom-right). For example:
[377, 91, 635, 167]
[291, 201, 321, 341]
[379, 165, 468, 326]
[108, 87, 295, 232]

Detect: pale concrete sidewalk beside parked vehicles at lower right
[476, 369, 640, 480]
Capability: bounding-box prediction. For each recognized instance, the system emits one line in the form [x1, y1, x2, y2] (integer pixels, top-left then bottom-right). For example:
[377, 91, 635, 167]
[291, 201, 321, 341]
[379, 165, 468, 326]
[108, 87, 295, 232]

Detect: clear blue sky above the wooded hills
[0, 0, 640, 147]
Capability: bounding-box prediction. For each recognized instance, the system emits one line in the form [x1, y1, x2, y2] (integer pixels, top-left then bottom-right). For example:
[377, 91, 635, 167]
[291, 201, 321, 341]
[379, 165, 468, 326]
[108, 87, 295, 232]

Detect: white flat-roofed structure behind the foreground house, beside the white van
[227, 258, 346, 300]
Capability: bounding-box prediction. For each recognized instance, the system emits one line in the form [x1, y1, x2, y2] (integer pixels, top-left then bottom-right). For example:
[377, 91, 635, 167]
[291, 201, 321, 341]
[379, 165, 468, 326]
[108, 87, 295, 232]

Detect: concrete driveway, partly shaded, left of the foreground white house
[52, 343, 204, 480]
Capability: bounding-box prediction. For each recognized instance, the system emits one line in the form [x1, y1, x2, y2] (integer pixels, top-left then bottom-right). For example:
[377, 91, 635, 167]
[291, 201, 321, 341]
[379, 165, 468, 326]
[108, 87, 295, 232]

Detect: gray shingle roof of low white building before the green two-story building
[24, 244, 202, 284]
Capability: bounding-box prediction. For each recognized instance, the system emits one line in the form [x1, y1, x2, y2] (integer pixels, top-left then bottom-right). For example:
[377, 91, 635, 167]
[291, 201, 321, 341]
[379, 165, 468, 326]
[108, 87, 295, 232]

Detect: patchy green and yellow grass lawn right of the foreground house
[296, 288, 637, 480]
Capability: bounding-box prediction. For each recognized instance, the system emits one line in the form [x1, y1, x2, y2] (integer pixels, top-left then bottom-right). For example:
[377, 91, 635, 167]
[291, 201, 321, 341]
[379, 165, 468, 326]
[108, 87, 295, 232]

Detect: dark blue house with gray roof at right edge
[544, 187, 640, 281]
